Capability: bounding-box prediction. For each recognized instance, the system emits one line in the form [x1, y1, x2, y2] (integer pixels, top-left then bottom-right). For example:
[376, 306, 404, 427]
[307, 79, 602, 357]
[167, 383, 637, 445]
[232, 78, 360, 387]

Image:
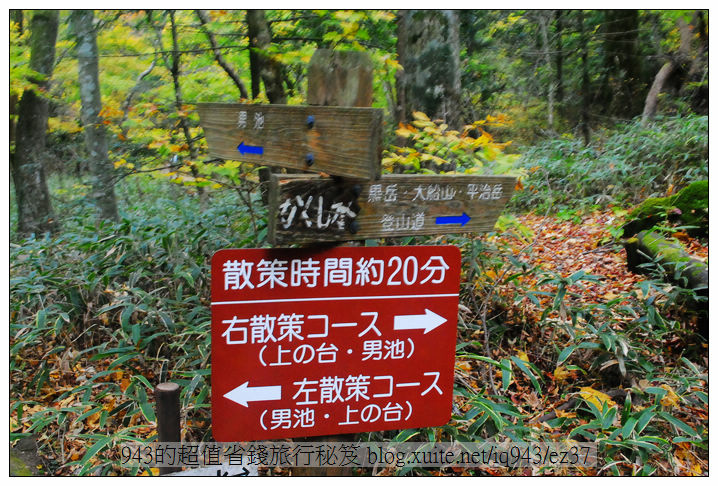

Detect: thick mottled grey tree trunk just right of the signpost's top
[397, 10, 463, 128]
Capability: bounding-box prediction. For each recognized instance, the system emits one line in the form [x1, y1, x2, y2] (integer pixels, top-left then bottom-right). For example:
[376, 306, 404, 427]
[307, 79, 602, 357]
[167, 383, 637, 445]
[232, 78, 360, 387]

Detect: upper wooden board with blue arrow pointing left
[197, 103, 382, 180]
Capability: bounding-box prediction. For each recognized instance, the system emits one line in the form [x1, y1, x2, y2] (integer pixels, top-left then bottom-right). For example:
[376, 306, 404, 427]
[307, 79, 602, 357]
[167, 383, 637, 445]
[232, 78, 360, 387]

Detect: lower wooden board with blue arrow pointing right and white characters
[268, 174, 516, 245]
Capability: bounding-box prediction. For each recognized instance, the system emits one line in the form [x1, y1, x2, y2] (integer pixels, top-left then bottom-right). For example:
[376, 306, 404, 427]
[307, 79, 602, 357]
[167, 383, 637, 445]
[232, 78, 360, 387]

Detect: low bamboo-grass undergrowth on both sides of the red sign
[10, 112, 708, 475]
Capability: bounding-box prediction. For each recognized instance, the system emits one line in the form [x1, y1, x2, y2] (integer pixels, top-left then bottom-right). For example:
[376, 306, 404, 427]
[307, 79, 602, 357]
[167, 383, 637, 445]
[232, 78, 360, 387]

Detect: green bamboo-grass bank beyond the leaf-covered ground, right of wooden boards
[513, 116, 708, 213]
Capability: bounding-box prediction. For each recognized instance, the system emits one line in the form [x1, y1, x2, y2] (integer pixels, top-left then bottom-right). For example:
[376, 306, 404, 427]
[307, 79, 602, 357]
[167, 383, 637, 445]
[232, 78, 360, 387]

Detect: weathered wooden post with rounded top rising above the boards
[292, 49, 381, 476]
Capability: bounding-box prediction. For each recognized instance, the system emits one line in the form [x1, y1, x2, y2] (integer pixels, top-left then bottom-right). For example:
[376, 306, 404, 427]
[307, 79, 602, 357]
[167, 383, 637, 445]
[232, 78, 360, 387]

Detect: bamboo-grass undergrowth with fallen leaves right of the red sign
[434, 213, 708, 475]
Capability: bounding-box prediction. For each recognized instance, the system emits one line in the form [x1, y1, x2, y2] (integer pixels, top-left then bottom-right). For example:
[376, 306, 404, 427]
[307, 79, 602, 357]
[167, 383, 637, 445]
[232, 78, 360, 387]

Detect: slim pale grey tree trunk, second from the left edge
[71, 10, 119, 221]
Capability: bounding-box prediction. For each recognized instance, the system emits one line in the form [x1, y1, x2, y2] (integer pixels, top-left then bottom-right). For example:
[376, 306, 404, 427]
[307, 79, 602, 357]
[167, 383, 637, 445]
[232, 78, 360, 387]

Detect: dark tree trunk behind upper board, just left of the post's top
[247, 10, 287, 104]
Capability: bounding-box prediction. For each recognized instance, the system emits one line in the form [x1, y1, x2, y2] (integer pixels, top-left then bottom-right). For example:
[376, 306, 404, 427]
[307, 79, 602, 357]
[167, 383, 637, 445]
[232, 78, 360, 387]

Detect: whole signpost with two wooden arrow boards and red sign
[198, 51, 516, 475]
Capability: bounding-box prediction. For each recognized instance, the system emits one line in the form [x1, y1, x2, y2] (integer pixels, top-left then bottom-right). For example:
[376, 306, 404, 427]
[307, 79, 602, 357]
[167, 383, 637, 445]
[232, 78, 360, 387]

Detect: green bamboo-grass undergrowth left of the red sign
[10, 178, 266, 474]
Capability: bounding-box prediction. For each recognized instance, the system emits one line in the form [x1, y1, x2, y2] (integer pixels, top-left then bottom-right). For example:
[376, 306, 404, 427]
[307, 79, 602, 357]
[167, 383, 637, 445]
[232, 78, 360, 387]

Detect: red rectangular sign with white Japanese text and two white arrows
[212, 246, 461, 442]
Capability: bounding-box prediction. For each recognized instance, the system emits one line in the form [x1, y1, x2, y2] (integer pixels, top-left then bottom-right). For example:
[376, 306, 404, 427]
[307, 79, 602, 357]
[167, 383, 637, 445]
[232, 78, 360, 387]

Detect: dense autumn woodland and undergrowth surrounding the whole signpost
[9, 10, 708, 475]
